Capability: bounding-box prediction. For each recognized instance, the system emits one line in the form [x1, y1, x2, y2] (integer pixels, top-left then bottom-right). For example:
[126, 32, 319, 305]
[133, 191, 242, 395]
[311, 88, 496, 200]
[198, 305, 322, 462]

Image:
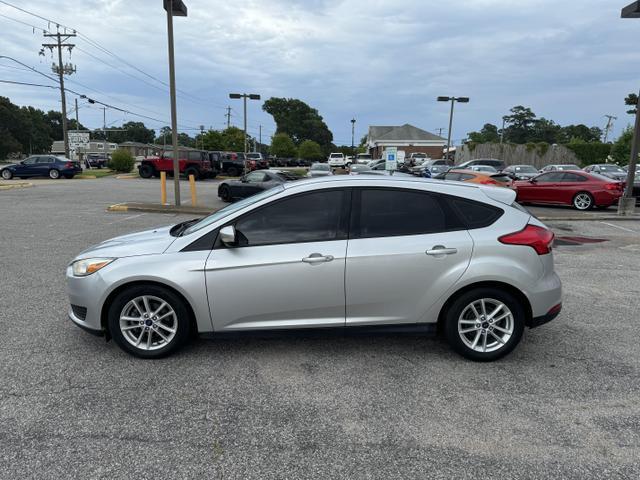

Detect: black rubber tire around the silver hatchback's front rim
[108, 285, 191, 359]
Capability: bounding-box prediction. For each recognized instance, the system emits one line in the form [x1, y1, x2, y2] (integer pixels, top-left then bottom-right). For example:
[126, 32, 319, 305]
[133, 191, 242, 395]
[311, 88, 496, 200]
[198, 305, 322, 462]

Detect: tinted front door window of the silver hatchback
[236, 190, 345, 246]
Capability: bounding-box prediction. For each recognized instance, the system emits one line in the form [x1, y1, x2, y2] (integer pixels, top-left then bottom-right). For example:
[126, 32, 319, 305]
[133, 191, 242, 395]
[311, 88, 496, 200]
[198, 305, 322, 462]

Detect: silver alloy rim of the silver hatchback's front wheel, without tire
[119, 295, 178, 350]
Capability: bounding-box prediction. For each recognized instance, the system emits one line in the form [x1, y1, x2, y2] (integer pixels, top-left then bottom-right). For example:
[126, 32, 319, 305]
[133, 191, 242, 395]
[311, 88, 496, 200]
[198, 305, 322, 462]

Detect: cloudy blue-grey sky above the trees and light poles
[0, 0, 640, 144]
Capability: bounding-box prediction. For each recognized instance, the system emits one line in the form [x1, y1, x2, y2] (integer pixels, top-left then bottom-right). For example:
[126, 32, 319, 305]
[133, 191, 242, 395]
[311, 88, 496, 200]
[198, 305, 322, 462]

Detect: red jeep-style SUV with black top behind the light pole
[138, 150, 217, 180]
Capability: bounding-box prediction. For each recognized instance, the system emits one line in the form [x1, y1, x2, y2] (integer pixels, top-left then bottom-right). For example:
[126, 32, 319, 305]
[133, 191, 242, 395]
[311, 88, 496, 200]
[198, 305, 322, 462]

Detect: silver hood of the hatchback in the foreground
[76, 226, 176, 258]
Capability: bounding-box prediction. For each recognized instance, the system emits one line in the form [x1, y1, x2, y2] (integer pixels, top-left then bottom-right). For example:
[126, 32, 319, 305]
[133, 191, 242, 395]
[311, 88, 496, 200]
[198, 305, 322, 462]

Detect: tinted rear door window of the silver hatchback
[352, 189, 453, 238]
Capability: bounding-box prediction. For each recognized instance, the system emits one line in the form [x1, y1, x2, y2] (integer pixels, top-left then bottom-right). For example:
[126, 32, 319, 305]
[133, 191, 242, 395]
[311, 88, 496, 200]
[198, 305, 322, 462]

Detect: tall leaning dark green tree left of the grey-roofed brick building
[262, 97, 333, 153]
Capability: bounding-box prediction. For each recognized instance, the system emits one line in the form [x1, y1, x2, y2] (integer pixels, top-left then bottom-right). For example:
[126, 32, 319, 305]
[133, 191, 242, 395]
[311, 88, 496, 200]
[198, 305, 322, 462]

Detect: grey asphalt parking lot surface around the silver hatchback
[0, 179, 640, 479]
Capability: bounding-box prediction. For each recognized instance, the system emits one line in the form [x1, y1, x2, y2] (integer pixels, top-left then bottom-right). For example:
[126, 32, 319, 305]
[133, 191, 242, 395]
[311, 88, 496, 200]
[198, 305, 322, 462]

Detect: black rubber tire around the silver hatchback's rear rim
[444, 288, 525, 362]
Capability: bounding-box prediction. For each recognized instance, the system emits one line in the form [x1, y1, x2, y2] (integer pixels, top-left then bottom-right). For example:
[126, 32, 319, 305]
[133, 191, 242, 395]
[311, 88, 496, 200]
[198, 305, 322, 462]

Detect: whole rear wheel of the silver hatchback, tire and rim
[445, 288, 525, 362]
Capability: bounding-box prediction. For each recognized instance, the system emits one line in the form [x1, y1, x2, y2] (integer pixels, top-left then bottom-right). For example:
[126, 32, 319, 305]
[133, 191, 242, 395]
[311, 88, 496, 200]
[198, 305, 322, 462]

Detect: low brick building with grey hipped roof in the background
[367, 123, 447, 158]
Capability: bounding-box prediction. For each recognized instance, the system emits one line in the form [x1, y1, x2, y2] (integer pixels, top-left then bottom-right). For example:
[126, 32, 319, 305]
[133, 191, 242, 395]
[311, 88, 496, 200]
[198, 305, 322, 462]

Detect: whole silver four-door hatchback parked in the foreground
[67, 175, 562, 361]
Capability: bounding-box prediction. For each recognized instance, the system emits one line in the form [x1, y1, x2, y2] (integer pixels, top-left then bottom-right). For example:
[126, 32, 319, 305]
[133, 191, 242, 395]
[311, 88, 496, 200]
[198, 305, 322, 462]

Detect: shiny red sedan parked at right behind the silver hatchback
[513, 171, 624, 210]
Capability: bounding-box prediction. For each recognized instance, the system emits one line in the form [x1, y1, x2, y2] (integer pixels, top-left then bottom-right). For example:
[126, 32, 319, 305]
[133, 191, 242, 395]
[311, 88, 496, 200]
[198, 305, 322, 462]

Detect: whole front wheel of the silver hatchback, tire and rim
[108, 285, 191, 358]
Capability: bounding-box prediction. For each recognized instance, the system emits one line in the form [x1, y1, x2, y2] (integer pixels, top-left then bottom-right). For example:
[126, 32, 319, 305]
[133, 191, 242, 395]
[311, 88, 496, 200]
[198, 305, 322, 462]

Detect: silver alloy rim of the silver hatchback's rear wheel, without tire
[458, 298, 514, 353]
